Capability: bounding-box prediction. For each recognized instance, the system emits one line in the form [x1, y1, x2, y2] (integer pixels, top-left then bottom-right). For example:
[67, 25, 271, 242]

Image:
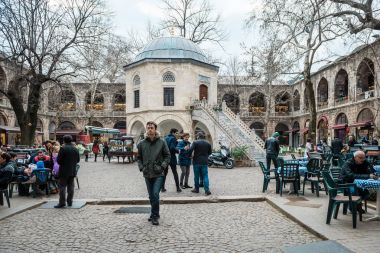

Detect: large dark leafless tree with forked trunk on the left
[0, 0, 106, 145]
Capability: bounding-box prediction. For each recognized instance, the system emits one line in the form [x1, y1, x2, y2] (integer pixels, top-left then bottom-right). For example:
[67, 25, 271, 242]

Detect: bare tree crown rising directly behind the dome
[161, 0, 227, 46]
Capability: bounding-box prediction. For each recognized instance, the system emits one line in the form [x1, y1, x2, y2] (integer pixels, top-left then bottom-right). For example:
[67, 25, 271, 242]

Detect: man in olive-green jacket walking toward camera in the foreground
[137, 121, 170, 225]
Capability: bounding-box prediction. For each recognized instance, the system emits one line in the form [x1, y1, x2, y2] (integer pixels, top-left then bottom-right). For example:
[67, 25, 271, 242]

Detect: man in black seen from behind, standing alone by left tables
[54, 135, 80, 208]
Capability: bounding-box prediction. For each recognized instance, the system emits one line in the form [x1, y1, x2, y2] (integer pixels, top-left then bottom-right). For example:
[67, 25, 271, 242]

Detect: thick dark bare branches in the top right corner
[330, 0, 380, 34]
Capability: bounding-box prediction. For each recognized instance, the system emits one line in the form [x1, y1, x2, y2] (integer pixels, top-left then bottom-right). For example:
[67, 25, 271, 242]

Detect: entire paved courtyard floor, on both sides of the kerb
[0, 158, 380, 252]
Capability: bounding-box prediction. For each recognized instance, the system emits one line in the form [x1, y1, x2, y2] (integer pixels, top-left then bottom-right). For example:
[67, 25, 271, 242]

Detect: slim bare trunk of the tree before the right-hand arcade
[304, 72, 317, 144]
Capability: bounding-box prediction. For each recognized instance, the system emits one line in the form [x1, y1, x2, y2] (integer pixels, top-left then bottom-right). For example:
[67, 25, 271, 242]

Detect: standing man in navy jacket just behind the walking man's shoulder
[162, 128, 182, 192]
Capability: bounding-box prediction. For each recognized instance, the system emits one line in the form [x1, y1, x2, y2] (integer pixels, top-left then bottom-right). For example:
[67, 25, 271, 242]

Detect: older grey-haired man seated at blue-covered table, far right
[340, 150, 378, 211]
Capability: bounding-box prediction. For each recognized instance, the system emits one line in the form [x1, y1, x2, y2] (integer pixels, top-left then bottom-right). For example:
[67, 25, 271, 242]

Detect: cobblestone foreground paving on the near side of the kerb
[0, 202, 320, 253]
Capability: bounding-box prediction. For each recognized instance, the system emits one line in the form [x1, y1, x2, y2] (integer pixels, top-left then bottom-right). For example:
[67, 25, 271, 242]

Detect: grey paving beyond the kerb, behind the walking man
[72, 160, 273, 199]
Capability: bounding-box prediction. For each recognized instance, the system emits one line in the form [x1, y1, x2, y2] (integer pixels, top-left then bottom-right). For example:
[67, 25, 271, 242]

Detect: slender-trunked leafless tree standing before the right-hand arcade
[254, 0, 347, 141]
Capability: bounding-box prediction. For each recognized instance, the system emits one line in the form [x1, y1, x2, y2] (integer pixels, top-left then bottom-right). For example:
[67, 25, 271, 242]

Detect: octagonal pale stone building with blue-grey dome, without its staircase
[124, 37, 218, 136]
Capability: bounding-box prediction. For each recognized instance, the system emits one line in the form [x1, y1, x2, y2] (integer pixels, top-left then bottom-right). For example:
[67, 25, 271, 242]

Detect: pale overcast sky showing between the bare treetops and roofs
[106, 0, 380, 75]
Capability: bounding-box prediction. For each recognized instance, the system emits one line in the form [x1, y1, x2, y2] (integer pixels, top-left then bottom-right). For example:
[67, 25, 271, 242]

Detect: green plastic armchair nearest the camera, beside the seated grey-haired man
[322, 171, 362, 228]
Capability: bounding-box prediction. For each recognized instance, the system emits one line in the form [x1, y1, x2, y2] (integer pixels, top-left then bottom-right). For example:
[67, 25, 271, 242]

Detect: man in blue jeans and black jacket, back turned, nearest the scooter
[189, 132, 211, 195]
